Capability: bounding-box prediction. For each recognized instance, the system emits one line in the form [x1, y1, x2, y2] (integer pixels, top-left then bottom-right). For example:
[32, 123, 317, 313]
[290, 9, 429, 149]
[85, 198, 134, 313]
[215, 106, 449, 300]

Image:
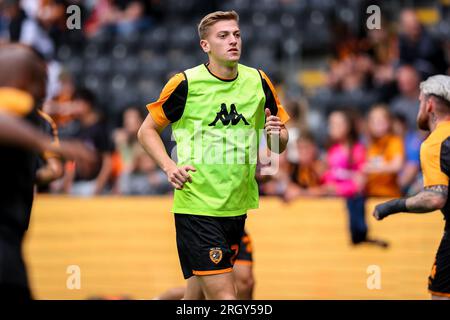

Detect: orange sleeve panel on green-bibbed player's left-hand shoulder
[147, 73, 186, 128]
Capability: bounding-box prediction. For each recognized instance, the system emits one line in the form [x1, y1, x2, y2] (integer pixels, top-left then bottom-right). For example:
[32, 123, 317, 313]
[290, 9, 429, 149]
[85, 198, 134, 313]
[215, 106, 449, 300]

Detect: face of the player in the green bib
[200, 20, 242, 64]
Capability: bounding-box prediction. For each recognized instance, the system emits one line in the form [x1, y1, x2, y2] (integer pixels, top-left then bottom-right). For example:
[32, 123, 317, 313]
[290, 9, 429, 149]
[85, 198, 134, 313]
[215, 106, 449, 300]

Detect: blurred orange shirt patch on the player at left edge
[0, 87, 34, 117]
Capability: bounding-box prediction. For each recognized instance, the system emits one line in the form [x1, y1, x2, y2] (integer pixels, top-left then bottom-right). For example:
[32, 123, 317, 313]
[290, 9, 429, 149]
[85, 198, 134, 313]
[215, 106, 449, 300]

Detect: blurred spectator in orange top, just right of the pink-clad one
[364, 105, 404, 197]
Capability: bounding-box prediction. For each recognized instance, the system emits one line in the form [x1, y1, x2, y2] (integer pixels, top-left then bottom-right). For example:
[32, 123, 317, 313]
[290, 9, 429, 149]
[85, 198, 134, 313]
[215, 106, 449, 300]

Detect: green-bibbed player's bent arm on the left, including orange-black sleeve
[138, 73, 195, 190]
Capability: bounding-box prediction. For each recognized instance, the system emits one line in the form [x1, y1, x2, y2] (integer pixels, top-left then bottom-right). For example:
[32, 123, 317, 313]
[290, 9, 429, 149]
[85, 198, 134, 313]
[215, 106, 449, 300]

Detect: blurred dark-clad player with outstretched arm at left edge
[0, 44, 93, 300]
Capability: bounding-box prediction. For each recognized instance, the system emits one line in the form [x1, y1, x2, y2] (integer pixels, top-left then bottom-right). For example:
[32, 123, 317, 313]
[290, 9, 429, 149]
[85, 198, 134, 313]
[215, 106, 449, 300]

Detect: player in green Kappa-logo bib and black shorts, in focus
[138, 11, 289, 299]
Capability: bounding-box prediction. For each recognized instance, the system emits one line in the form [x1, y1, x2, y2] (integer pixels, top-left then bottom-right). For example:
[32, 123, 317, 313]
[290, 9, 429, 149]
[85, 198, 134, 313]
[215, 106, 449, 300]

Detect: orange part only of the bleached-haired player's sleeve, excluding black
[420, 141, 449, 187]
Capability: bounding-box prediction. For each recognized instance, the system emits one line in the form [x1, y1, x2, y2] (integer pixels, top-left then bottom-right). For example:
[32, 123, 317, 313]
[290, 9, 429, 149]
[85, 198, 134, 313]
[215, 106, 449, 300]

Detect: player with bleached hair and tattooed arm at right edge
[373, 75, 450, 299]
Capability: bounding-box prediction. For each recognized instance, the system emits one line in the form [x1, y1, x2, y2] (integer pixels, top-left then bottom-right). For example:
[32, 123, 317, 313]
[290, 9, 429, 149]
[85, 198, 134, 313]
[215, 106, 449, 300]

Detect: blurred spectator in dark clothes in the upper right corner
[399, 9, 448, 79]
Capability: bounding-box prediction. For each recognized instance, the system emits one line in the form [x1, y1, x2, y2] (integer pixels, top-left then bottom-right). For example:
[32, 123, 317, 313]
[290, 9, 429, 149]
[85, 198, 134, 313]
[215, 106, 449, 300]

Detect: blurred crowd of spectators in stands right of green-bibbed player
[260, 8, 450, 205]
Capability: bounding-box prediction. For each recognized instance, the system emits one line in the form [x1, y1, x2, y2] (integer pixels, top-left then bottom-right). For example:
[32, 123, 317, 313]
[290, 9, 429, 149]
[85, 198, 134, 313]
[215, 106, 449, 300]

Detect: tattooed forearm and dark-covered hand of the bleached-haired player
[373, 185, 448, 220]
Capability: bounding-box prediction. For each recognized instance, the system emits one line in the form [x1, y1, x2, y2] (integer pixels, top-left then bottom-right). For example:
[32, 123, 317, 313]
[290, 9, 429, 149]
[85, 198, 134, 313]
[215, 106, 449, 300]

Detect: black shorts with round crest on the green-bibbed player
[175, 213, 247, 279]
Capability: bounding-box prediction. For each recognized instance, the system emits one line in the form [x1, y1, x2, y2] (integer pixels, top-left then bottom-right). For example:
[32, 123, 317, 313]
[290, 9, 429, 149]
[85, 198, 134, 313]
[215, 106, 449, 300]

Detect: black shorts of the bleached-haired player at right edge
[428, 231, 450, 297]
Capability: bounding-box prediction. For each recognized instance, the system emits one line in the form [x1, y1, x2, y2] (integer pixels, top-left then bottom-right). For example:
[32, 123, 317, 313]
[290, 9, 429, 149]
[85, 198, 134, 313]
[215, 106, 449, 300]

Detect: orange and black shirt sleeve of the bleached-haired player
[420, 138, 450, 187]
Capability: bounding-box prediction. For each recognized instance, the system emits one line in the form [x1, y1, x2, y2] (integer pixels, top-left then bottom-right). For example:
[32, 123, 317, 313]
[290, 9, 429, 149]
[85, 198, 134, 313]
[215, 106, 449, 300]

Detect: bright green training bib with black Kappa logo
[172, 64, 265, 217]
